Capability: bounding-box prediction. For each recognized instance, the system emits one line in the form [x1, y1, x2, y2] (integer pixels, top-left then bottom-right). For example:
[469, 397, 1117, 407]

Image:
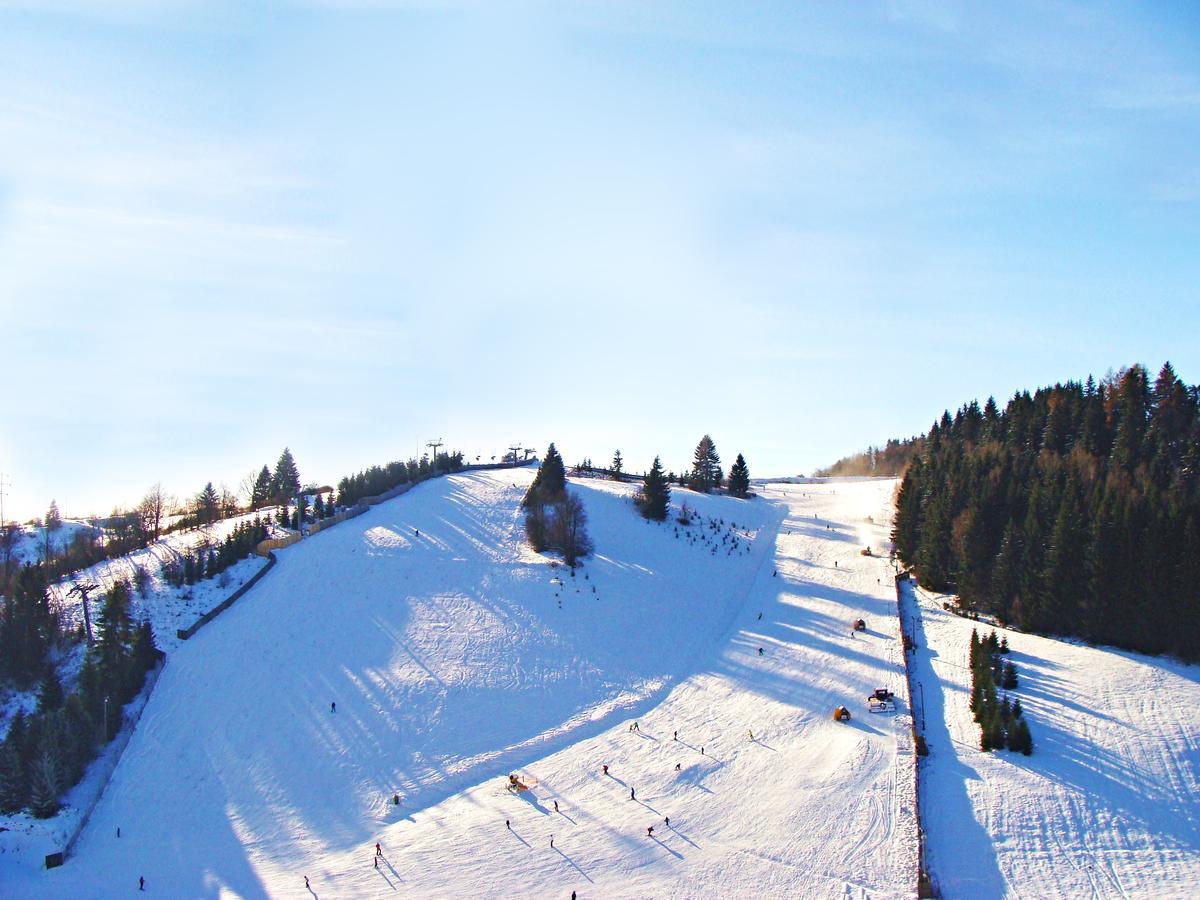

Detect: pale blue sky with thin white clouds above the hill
[0, 0, 1200, 517]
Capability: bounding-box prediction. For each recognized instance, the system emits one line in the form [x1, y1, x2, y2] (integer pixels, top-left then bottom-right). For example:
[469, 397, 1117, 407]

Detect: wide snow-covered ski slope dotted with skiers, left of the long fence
[7, 470, 916, 898]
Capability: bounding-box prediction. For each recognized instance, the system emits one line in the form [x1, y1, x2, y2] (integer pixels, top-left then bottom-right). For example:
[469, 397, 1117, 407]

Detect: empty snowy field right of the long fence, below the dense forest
[906, 580, 1200, 898]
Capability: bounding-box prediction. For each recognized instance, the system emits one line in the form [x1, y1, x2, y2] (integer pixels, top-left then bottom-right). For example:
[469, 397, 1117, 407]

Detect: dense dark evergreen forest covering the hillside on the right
[893, 364, 1200, 660]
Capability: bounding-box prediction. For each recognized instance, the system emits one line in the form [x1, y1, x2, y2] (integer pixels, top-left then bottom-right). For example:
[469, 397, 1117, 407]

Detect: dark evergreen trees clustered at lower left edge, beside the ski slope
[0, 578, 162, 817]
